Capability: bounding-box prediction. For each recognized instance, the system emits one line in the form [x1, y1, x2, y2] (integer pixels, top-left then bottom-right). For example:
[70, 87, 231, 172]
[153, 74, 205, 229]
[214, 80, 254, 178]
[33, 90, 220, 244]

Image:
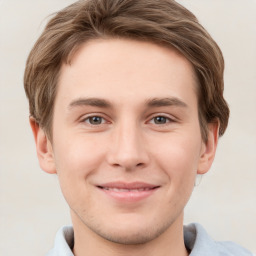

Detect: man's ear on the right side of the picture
[197, 120, 219, 174]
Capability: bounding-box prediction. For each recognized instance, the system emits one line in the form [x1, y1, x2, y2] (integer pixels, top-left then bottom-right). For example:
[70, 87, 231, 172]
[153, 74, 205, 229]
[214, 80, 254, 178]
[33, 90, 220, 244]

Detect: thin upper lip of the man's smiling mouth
[97, 181, 160, 189]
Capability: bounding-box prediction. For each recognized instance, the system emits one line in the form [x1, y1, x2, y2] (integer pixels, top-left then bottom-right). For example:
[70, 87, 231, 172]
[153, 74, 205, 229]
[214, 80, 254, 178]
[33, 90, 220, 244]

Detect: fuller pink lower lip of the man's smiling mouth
[99, 188, 158, 202]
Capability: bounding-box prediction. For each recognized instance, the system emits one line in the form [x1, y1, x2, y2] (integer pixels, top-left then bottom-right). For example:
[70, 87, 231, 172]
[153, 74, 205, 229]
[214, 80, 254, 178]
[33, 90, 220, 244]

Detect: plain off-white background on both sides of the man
[0, 0, 256, 256]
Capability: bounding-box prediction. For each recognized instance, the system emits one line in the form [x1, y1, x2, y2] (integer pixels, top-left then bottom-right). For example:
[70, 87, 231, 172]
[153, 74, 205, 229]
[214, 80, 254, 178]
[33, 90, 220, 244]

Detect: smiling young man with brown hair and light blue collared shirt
[24, 0, 252, 256]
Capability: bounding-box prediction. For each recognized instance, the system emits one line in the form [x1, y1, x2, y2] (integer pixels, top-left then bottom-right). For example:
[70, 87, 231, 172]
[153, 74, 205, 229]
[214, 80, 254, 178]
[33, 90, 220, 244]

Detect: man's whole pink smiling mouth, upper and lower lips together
[97, 182, 160, 202]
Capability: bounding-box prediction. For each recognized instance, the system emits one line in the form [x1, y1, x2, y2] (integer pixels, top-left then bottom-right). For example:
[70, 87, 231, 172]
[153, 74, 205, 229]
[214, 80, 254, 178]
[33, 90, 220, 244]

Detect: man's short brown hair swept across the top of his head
[24, 0, 229, 141]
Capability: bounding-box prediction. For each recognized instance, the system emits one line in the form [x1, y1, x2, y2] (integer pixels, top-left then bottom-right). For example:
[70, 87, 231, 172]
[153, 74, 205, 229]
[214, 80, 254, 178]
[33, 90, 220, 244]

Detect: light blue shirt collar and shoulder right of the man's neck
[184, 223, 253, 256]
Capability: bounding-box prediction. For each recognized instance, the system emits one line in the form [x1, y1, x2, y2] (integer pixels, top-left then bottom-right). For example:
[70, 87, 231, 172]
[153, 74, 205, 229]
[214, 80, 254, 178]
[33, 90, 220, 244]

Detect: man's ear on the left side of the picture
[29, 117, 56, 174]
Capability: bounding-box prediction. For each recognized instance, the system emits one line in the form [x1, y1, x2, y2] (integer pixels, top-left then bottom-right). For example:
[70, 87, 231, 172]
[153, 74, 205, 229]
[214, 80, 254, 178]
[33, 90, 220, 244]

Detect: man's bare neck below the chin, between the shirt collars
[72, 211, 188, 256]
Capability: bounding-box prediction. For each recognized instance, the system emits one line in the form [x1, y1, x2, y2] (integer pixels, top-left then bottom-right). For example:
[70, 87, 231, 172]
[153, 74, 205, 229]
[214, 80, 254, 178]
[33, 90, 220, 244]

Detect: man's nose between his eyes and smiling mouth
[108, 121, 150, 171]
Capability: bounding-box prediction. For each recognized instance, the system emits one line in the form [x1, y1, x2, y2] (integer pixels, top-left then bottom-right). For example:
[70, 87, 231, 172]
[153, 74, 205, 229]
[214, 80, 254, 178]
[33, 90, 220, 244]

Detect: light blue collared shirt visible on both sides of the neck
[46, 223, 253, 256]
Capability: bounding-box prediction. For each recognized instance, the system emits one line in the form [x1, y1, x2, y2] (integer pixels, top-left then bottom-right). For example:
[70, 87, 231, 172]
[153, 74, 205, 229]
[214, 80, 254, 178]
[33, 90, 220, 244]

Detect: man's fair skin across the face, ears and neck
[30, 39, 218, 256]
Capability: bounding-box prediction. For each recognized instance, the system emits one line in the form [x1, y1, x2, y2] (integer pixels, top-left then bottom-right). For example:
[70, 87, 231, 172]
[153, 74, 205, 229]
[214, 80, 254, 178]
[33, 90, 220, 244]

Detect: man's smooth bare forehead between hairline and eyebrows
[57, 39, 197, 106]
